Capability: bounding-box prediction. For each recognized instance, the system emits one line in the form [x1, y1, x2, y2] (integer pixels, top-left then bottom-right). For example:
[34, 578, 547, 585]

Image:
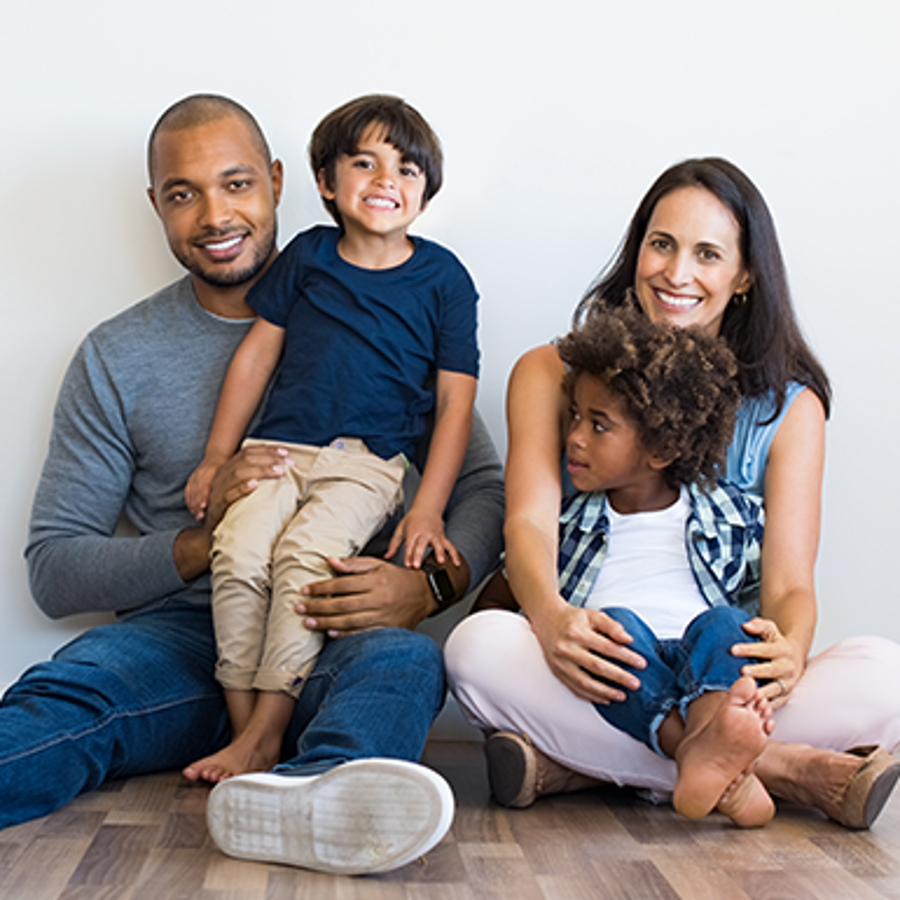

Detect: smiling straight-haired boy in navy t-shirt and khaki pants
[185, 95, 478, 782]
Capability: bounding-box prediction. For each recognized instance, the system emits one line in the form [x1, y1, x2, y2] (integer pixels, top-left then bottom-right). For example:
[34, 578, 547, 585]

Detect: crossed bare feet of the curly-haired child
[672, 676, 772, 820]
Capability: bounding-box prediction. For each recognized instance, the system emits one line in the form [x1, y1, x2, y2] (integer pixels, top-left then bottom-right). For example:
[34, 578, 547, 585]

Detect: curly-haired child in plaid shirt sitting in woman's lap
[558, 308, 774, 827]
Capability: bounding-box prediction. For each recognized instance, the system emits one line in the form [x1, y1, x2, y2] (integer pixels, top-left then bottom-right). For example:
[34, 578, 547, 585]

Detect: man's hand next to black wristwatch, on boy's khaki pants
[296, 556, 469, 637]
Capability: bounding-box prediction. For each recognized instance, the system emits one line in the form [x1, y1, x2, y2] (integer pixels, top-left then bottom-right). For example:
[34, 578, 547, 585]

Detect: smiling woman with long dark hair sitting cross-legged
[446, 159, 900, 828]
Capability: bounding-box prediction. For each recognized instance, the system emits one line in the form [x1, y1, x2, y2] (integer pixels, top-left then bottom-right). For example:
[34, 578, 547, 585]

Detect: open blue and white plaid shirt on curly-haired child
[559, 481, 764, 616]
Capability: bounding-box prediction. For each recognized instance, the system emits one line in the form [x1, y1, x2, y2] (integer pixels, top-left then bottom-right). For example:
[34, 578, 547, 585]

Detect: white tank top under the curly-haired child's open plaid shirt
[585, 487, 709, 639]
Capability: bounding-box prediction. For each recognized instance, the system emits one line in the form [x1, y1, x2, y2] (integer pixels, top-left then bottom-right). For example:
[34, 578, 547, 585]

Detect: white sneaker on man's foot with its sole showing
[206, 759, 455, 875]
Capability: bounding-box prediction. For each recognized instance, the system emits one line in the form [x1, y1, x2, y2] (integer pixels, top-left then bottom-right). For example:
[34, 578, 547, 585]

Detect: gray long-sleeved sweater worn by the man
[25, 277, 503, 618]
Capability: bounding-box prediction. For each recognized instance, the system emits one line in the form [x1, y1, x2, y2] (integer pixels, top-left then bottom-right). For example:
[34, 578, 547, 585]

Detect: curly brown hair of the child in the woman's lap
[557, 305, 741, 487]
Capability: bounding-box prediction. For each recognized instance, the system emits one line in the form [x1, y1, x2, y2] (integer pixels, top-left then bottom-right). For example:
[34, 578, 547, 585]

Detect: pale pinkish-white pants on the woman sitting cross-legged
[444, 609, 900, 792]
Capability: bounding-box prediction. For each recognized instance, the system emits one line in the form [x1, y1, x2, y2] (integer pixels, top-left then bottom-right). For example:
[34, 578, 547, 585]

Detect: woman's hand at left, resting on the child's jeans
[532, 600, 646, 704]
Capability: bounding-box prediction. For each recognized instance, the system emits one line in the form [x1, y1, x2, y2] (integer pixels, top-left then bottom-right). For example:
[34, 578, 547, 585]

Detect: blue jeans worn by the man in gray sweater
[0, 603, 444, 828]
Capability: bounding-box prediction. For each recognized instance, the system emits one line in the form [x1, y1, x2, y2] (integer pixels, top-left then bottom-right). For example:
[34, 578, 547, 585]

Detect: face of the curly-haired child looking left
[566, 374, 660, 500]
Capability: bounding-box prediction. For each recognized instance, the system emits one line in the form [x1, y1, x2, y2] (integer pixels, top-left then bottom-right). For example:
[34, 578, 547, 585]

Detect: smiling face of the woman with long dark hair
[634, 187, 750, 334]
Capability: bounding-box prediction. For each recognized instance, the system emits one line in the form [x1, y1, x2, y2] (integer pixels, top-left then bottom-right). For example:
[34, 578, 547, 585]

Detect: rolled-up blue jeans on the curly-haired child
[595, 606, 755, 756]
